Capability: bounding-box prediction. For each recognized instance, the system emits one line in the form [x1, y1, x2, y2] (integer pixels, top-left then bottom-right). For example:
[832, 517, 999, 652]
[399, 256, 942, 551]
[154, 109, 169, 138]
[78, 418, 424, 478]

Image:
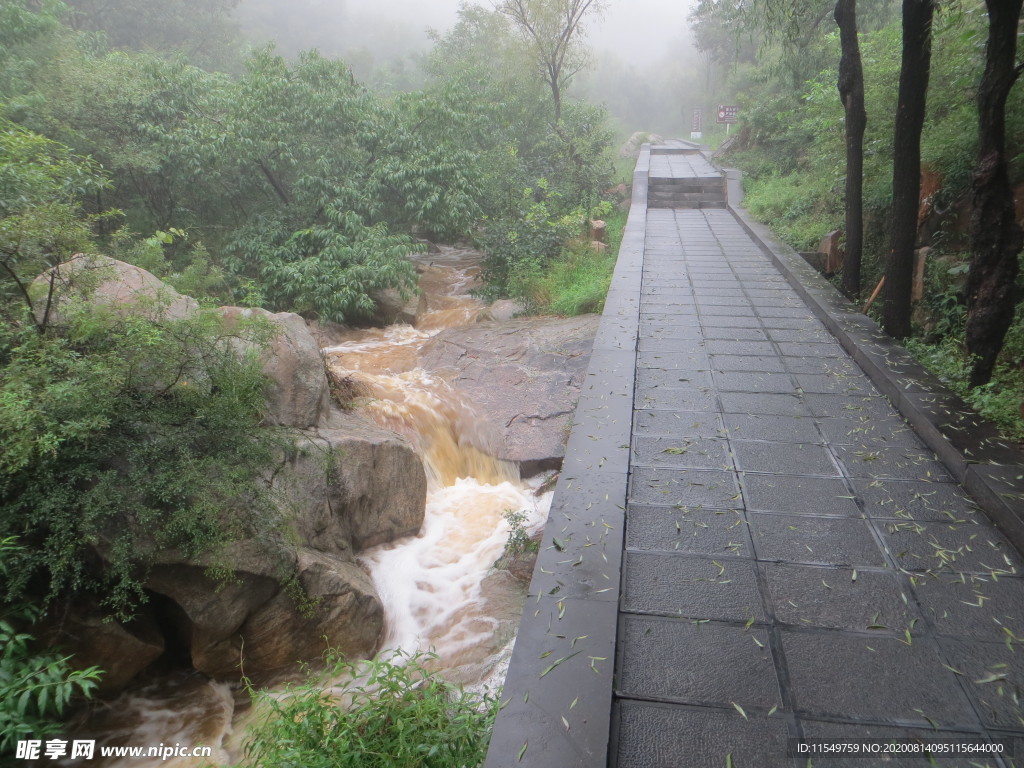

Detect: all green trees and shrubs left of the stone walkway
[0, 0, 611, 749]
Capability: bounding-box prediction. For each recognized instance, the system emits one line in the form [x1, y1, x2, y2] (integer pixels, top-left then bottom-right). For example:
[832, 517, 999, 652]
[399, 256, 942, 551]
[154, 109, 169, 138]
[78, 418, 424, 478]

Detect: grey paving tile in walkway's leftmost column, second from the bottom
[618, 614, 782, 711]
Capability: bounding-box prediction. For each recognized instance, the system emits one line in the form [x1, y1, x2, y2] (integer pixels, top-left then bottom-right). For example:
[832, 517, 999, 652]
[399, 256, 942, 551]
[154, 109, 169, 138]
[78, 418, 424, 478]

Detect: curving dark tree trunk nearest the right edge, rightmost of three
[966, 0, 1024, 386]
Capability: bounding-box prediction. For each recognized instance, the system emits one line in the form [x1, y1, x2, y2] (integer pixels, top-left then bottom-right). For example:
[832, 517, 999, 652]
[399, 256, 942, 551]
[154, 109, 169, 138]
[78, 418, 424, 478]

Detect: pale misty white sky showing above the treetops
[234, 0, 707, 135]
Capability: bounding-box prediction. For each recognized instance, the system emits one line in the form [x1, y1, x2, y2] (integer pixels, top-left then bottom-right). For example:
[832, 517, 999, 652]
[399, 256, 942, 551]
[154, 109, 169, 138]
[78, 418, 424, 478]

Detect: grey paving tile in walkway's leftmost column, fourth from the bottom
[626, 504, 753, 557]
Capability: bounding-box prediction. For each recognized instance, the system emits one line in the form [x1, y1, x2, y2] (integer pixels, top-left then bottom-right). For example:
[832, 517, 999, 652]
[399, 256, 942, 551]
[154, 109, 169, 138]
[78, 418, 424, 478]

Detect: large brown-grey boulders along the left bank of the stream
[34, 257, 426, 692]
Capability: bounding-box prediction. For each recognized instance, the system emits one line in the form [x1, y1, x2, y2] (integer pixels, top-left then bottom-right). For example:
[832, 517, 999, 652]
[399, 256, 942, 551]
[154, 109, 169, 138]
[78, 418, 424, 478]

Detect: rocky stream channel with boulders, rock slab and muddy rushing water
[68, 248, 597, 766]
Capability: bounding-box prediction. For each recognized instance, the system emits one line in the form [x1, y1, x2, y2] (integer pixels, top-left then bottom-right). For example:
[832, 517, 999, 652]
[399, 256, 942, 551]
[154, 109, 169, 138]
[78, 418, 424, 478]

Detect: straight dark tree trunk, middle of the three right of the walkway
[882, 0, 936, 339]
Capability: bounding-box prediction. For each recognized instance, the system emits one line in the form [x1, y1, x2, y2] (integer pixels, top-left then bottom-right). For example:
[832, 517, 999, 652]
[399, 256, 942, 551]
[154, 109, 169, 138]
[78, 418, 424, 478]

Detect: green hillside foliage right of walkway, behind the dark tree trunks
[693, 0, 1024, 437]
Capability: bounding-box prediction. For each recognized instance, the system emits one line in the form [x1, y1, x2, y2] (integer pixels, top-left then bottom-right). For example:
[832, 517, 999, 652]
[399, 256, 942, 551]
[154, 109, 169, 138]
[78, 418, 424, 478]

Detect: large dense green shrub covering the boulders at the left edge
[0, 304, 287, 618]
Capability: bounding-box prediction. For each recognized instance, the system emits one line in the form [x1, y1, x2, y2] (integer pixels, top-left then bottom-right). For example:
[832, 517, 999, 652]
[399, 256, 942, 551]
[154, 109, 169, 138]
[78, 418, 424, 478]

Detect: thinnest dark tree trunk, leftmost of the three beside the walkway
[836, 0, 867, 301]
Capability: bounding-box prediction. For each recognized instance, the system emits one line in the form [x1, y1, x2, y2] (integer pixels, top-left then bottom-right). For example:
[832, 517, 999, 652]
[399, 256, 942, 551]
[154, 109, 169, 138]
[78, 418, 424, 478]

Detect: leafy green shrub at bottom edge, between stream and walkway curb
[237, 651, 498, 768]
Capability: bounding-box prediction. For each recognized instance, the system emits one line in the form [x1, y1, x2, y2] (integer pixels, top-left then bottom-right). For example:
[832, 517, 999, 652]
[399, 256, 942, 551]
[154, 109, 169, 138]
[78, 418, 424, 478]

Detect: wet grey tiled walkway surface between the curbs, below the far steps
[609, 209, 1024, 768]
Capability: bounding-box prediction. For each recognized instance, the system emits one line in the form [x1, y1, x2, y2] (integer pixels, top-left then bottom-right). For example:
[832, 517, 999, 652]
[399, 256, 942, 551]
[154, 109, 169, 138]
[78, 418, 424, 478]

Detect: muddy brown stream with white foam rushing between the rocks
[68, 248, 550, 768]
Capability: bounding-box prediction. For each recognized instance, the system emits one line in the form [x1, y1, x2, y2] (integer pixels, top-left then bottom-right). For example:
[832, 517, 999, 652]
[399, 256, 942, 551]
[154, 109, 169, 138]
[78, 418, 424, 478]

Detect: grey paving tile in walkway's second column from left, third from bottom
[762, 563, 919, 634]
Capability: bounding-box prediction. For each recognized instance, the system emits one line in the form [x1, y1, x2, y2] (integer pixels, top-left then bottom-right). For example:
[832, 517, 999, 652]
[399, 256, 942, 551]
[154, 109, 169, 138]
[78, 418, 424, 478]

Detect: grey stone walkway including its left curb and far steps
[487, 143, 1024, 768]
